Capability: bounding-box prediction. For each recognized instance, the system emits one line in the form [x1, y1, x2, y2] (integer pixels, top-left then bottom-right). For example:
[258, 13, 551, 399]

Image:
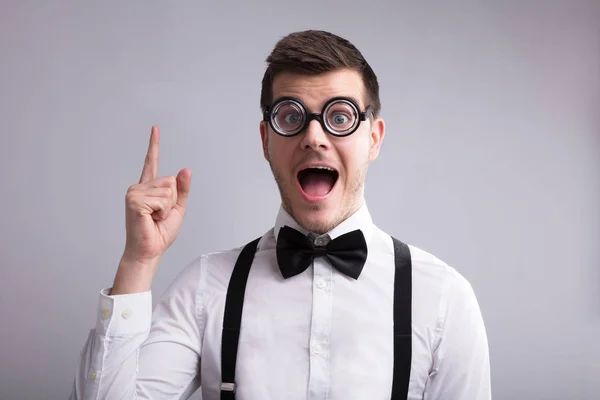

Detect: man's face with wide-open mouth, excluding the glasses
[260, 69, 385, 234]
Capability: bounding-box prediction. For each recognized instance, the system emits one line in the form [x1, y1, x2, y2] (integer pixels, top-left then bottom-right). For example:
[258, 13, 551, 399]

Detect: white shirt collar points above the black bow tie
[273, 201, 373, 243]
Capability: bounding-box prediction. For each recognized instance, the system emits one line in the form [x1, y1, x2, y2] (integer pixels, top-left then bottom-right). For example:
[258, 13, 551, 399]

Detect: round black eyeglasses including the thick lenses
[263, 97, 373, 136]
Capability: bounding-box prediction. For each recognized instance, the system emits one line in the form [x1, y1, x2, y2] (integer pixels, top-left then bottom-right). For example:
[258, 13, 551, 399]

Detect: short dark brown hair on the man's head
[260, 30, 381, 117]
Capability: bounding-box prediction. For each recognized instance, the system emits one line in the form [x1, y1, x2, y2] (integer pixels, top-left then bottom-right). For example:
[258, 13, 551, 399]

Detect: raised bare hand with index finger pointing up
[123, 126, 192, 265]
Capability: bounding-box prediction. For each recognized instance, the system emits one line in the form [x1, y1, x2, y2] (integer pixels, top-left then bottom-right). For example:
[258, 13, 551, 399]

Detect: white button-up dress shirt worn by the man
[71, 205, 491, 400]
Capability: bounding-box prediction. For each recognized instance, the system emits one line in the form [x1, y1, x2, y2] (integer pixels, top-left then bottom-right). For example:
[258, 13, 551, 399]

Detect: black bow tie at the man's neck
[277, 226, 367, 279]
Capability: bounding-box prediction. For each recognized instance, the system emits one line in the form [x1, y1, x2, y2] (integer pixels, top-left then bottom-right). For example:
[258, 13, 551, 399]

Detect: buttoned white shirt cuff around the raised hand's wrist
[96, 288, 152, 336]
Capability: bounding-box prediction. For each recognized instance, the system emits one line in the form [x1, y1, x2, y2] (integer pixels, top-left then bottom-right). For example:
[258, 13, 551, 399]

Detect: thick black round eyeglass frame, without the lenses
[263, 96, 373, 137]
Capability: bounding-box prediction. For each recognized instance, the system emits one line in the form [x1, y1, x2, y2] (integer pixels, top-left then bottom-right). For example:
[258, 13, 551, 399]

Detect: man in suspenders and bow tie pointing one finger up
[72, 31, 491, 400]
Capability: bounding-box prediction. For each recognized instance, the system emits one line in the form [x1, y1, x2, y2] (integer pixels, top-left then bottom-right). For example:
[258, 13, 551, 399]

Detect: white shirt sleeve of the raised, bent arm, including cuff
[70, 259, 204, 400]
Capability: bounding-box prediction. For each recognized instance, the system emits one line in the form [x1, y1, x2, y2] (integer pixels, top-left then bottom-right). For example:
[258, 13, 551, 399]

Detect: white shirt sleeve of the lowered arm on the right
[424, 271, 492, 400]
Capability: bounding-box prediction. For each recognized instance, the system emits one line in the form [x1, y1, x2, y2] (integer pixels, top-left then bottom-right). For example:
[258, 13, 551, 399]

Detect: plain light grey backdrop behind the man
[0, 0, 600, 400]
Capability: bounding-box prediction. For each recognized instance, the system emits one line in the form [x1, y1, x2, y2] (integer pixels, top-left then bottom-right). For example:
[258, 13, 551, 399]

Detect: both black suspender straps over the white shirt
[221, 237, 412, 400]
